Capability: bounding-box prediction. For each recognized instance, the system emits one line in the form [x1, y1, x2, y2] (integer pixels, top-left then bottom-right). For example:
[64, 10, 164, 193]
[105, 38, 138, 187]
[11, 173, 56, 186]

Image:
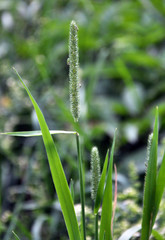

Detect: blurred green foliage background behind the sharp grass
[0, 0, 165, 240]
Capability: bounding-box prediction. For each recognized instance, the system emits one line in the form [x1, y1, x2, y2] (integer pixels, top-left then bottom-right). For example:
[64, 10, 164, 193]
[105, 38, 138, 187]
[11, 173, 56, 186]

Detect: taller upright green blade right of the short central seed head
[99, 131, 116, 240]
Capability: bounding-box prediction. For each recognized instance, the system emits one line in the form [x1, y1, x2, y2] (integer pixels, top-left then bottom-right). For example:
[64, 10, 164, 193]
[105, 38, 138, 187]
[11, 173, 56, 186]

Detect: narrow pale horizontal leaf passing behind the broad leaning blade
[0, 130, 76, 137]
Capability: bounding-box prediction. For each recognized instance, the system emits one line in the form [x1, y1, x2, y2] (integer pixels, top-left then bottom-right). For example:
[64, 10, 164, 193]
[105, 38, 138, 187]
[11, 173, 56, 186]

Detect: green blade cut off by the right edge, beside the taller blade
[152, 153, 165, 226]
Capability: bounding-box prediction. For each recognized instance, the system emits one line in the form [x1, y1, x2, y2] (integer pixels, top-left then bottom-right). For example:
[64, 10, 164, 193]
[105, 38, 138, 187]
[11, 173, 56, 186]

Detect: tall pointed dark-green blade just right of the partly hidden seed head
[141, 107, 158, 240]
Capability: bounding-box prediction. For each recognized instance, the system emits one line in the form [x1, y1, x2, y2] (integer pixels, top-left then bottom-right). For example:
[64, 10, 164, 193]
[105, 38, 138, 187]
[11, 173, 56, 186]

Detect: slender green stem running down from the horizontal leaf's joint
[76, 133, 86, 240]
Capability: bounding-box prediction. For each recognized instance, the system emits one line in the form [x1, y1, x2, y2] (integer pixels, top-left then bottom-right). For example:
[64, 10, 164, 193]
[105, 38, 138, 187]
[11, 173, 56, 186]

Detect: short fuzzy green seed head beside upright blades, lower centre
[91, 147, 100, 201]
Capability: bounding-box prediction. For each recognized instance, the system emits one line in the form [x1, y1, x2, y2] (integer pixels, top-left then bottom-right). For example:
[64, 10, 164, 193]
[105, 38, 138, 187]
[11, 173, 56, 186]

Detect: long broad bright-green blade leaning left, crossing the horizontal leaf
[14, 69, 80, 240]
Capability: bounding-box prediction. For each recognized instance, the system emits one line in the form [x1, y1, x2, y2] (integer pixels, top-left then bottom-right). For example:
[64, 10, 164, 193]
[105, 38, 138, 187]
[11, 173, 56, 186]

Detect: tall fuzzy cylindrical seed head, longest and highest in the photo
[69, 21, 80, 122]
